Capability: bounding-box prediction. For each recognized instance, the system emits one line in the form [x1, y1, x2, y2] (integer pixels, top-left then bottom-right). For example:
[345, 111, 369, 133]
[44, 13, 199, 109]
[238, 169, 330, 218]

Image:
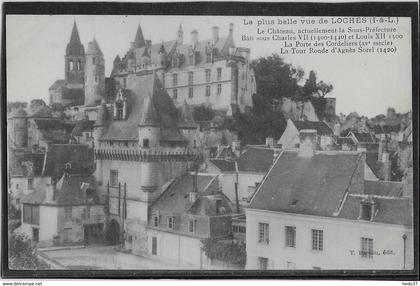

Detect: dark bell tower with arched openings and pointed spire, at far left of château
[64, 22, 85, 84]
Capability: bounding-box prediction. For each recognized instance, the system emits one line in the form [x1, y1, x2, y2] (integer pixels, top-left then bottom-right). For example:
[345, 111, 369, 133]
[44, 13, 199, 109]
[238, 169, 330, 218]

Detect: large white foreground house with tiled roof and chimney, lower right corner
[245, 130, 414, 270]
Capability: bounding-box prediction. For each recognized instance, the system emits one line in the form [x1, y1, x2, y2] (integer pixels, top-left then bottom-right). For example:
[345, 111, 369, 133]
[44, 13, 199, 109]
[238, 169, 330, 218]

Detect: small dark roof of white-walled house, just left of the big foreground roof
[238, 147, 274, 173]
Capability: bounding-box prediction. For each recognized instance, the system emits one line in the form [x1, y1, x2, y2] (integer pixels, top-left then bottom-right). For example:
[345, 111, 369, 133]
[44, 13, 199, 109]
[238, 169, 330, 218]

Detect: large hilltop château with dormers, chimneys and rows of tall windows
[111, 24, 256, 112]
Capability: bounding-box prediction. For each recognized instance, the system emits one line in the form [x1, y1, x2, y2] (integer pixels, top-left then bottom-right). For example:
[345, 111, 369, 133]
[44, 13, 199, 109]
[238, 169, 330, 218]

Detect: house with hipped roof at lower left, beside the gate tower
[20, 169, 105, 247]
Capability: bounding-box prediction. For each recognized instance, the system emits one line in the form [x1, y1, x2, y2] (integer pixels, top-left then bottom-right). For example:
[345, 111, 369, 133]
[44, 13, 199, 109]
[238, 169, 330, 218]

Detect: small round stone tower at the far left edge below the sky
[9, 108, 28, 148]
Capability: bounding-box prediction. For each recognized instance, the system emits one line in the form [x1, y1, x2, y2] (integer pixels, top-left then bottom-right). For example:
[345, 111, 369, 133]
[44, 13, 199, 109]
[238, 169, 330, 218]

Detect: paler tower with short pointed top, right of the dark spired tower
[85, 38, 105, 106]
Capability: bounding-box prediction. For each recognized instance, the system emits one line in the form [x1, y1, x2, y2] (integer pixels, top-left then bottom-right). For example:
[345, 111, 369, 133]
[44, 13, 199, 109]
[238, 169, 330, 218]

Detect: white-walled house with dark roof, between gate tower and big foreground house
[207, 146, 275, 206]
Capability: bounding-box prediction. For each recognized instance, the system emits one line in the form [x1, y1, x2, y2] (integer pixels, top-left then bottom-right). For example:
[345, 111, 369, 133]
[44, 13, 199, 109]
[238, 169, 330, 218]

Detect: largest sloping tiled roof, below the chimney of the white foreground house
[250, 151, 363, 216]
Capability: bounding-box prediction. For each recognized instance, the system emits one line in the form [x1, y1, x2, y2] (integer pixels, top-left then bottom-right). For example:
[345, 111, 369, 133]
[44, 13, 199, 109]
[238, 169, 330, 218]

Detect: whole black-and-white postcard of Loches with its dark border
[3, 3, 418, 276]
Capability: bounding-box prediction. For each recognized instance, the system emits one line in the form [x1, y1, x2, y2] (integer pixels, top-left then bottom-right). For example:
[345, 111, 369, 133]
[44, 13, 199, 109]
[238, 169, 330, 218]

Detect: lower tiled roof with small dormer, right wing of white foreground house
[338, 194, 413, 226]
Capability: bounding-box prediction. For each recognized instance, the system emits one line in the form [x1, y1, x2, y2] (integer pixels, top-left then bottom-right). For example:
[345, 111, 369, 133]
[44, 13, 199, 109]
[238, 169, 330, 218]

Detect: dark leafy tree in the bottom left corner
[9, 233, 48, 270]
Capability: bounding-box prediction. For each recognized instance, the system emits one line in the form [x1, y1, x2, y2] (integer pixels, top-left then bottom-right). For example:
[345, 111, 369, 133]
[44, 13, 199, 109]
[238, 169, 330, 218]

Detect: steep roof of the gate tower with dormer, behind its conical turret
[100, 74, 186, 141]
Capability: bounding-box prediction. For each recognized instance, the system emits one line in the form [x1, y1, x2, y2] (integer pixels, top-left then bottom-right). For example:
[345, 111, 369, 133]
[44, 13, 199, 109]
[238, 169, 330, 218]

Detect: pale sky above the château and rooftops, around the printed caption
[6, 15, 412, 116]
